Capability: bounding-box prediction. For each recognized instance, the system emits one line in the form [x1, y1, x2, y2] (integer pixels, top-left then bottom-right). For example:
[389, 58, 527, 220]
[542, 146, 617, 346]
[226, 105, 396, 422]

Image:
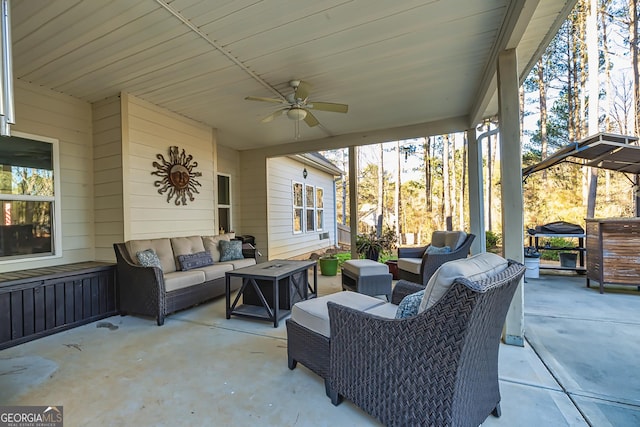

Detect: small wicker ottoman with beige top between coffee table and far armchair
[342, 259, 393, 301]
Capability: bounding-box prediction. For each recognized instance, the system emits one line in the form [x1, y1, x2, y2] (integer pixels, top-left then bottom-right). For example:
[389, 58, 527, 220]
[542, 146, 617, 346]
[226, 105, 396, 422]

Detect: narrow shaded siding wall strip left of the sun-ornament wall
[92, 96, 124, 262]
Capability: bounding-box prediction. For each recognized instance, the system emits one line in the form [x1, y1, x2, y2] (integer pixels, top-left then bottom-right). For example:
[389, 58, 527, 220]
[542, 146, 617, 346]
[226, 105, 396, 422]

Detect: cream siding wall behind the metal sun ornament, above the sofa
[121, 93, 217, 240]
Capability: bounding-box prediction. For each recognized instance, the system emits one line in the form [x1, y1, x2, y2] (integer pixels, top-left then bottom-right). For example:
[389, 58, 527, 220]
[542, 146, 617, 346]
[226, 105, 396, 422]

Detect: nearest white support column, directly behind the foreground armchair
[498, 49, 524, 346]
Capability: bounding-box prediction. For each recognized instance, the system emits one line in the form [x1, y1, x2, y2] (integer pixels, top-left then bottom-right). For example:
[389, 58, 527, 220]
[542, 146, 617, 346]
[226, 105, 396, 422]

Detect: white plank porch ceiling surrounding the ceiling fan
[12, 0, 576, 154]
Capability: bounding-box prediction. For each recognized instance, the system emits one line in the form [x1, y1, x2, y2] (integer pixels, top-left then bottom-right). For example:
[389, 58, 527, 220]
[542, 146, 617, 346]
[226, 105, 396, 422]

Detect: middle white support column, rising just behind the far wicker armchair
[467, 129, 487, 255]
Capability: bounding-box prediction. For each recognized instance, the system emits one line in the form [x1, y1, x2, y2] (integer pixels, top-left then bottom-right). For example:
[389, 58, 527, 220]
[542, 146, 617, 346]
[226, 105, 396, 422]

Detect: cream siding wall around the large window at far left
[0, 80, 94, 272]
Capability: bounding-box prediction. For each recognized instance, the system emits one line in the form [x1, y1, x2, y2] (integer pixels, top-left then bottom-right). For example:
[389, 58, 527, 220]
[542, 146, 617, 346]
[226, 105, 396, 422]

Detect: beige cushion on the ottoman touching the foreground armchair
[291, 291, 384, 337]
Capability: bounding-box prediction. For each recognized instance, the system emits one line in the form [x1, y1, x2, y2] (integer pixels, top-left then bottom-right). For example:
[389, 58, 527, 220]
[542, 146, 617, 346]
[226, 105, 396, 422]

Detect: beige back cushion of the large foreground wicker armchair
[418, 252, 508, 313]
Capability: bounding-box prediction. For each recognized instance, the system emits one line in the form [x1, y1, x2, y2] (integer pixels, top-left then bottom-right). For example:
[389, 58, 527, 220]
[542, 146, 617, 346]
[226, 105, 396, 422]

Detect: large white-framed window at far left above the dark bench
[0, 132, 62, 263]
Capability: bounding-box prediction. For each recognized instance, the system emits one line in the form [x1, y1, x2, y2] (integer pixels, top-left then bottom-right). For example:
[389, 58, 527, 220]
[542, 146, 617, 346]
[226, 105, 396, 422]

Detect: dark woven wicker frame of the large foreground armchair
[325, 261, 525, 426]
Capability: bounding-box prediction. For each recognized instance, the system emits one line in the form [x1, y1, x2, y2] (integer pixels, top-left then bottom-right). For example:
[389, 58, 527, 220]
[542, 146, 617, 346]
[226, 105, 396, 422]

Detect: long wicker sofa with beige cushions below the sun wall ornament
[113, 233, 256, 326]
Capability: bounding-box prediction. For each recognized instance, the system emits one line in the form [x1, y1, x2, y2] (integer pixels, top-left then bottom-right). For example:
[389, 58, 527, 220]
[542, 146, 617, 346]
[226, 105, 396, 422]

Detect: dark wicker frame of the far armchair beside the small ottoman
[398, 234, 476, 286]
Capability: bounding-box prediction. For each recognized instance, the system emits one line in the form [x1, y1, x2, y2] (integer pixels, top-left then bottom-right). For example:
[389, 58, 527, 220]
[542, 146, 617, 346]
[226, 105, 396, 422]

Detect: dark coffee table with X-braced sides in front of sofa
[225, 260, 318, 328]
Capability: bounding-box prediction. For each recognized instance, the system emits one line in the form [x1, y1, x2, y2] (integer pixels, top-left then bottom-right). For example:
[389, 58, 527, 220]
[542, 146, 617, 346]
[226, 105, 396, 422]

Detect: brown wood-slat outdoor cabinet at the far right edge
[586, 218, 640, 293]
